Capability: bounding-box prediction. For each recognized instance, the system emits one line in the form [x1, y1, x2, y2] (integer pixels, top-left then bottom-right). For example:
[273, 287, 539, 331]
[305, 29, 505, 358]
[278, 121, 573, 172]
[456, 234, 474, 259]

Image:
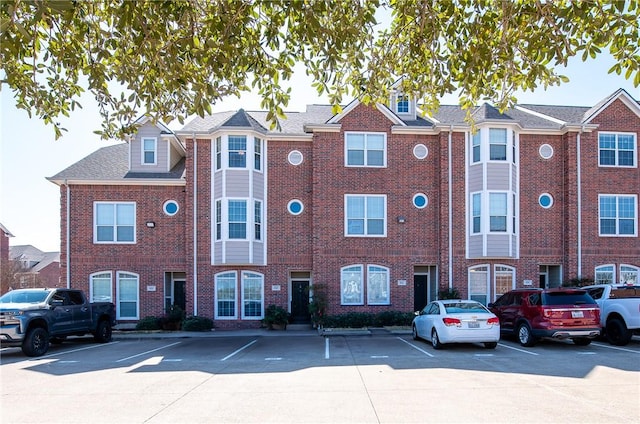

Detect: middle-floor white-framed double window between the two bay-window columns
[345, 194, 387, 237]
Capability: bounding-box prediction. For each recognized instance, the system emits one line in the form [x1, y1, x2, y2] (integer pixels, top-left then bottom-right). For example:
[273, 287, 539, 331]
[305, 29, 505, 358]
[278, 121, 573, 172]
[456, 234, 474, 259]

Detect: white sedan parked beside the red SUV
[411, 299, 500, 349]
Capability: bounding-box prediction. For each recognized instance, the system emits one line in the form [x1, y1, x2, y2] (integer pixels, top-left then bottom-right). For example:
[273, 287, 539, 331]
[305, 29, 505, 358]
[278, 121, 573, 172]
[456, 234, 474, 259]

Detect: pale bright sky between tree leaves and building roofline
[0, 55, 640, 251]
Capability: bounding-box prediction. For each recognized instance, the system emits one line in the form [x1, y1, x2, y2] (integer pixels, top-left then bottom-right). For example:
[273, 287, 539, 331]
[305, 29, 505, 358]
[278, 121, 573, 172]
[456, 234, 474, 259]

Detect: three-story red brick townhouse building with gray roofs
[50, 90, 640, 328]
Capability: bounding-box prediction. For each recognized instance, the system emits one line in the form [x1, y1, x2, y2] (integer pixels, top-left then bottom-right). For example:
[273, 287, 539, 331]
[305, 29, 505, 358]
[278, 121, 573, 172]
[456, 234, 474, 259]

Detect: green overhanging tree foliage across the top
[0, 0, 640, 138]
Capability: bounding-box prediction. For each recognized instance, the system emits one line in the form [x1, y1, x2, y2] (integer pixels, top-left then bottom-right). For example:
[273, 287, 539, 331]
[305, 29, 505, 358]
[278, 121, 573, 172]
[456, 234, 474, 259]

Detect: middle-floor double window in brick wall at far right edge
[598, 194, 638, 236]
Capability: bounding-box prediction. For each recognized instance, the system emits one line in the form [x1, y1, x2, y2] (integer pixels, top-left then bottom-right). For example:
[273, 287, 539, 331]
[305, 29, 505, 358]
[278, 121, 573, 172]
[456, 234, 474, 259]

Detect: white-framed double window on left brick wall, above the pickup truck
[93, 202, 136, 243]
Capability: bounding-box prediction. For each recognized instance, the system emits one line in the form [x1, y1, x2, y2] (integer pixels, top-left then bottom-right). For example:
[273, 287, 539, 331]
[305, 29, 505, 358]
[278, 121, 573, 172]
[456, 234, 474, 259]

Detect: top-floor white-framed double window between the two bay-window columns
[345, 132, 387, 168]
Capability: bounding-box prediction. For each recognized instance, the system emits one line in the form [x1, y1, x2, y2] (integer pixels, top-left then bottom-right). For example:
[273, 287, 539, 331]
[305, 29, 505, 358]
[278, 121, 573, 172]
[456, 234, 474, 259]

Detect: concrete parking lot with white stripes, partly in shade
[0, 331, 640, 423]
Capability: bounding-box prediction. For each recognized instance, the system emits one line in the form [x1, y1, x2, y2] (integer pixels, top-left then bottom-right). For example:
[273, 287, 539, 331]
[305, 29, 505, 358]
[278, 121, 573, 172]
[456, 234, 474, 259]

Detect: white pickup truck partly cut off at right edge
[582, 284, 640, 346]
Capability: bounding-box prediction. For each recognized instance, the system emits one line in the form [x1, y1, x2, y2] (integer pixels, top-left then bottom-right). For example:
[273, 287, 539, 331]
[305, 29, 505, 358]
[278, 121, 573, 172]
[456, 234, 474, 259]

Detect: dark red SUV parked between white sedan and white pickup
[489, 288, 601, 347]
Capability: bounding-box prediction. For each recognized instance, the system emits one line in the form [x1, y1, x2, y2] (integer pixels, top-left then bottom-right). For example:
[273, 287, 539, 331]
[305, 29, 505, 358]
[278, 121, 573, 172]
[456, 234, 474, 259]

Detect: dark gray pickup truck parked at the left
[0, 289, 116, 356]
